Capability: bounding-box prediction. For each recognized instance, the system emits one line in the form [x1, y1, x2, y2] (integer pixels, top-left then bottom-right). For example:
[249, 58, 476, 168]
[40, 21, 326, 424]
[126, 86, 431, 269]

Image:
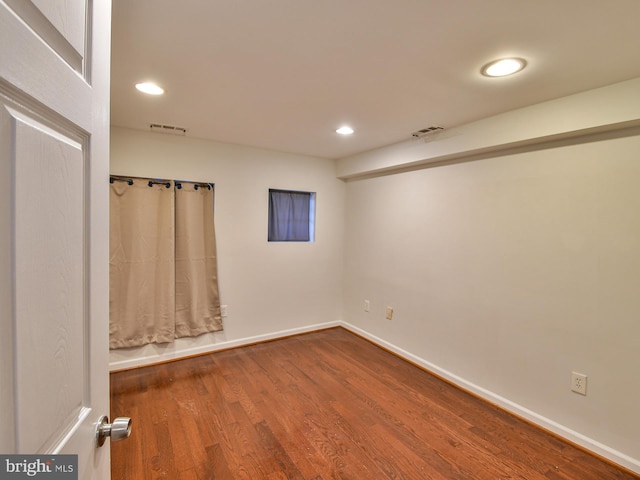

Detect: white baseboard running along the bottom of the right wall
[340, 322, 640, 474]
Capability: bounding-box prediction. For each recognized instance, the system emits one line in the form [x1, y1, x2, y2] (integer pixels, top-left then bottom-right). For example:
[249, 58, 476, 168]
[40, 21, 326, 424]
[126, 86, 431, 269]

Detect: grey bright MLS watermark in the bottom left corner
[0, 455, 78, 480]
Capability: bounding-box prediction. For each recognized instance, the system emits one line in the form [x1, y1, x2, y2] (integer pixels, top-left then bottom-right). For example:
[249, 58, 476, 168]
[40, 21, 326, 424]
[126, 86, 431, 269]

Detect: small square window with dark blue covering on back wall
[269, 188, 316, 242]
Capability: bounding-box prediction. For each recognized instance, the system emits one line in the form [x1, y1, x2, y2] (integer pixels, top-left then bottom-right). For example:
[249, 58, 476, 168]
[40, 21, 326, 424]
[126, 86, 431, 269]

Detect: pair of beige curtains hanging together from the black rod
[109, 177, 222, 349]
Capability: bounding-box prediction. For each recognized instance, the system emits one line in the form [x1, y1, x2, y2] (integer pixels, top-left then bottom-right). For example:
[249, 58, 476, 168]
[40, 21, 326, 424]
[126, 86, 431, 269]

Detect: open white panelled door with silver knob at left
[0, 0, 111, 479]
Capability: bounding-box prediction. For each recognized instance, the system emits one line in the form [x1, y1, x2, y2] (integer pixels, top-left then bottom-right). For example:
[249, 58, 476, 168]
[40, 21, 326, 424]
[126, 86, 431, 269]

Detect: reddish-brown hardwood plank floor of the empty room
[111, 328, 640, 480]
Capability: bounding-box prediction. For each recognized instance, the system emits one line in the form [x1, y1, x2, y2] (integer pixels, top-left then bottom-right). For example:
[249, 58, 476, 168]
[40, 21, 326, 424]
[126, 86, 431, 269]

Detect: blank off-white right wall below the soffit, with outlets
[338, 82, 640, 472]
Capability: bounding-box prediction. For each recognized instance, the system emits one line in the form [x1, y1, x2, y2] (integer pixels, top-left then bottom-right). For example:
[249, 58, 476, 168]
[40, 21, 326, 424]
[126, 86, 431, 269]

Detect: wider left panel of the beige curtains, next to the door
[109, 179, 175, 349]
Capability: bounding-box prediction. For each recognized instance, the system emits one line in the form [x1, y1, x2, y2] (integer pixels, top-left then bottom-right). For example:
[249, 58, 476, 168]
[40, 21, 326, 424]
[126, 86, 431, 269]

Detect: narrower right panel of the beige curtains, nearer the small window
[175, 183, 222, 337]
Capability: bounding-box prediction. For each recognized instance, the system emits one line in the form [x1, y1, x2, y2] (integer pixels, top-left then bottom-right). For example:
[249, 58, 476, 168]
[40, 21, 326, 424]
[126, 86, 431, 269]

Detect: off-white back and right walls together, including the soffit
[106, 80, 640, 472]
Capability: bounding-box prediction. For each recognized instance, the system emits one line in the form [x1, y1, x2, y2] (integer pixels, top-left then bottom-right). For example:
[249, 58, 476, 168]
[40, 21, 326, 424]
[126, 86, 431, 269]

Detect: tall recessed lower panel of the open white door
[8, 105, 89, 453]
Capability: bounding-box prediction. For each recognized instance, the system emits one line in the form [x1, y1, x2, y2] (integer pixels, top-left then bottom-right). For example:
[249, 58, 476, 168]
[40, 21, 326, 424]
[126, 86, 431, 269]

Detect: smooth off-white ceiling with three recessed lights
[111, 0, 640, 158]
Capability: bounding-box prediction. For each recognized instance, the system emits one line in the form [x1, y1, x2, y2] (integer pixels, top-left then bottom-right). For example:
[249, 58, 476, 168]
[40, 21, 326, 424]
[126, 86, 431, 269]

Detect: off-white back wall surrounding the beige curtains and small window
[105, 127, 345, 369]
